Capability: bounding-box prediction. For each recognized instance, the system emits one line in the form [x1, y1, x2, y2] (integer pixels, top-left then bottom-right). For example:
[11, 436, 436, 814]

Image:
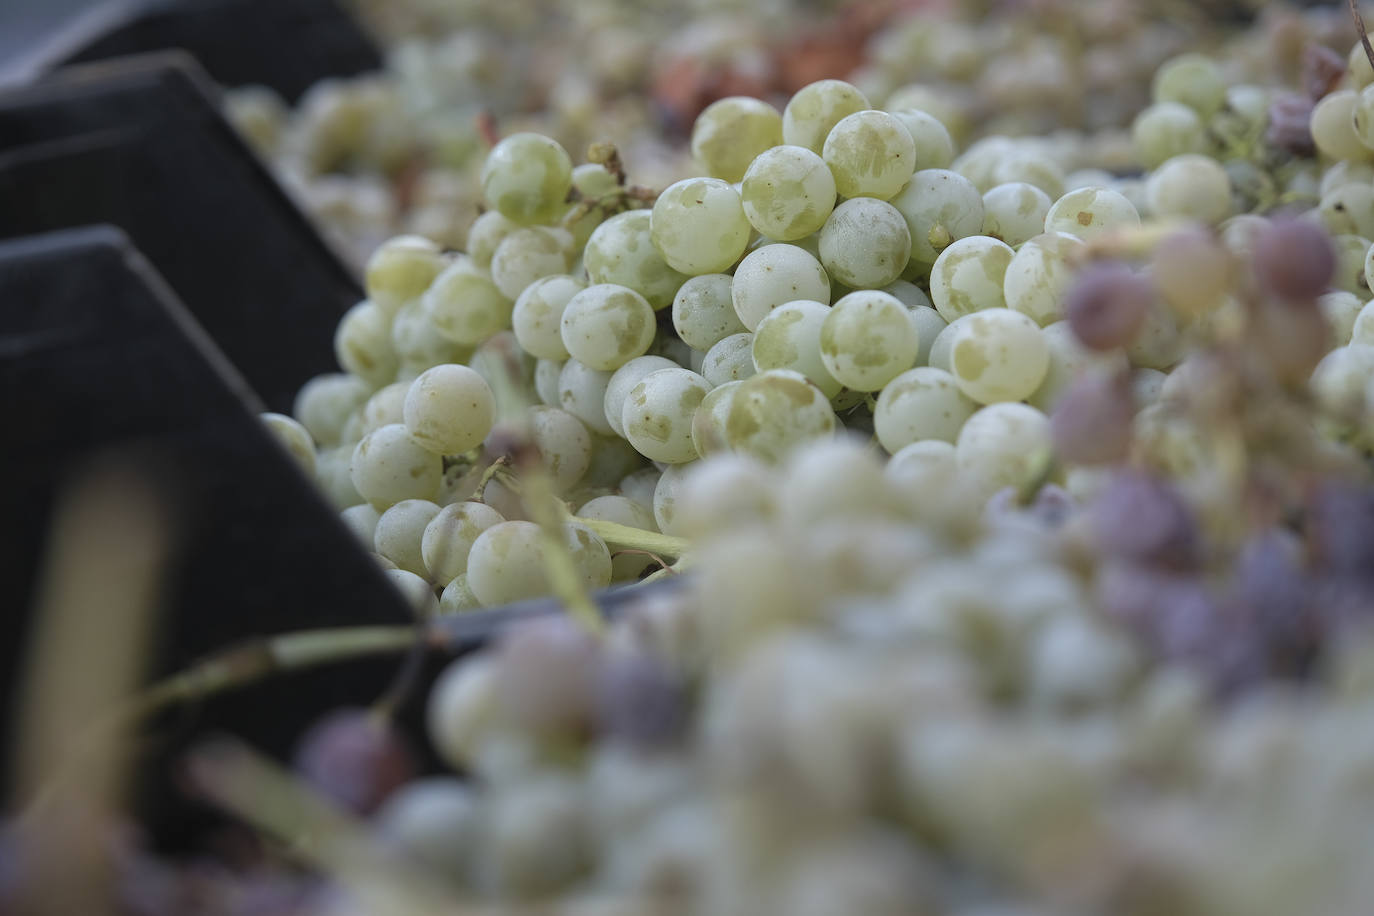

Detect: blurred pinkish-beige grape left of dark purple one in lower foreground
[496, 615, 600, 735]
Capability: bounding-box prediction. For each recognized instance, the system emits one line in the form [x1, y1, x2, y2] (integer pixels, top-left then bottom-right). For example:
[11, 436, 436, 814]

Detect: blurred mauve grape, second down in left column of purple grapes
[1050, 372, 1135, 464]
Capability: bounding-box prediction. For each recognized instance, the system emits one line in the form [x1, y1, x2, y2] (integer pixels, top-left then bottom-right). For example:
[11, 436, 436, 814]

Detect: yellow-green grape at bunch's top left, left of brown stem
[482, 133, 573, 225]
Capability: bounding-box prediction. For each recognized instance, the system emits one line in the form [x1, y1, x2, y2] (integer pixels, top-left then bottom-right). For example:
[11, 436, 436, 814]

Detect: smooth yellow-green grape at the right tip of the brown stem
[649, 179, 750, 274]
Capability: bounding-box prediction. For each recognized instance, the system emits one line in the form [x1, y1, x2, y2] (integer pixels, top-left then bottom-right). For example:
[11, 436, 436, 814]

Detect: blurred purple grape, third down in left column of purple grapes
[1090, 471, 1198, 569]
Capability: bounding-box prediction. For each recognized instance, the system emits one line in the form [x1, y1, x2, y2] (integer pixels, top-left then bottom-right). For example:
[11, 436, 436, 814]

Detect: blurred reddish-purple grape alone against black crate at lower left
[295, 709, 416, 814]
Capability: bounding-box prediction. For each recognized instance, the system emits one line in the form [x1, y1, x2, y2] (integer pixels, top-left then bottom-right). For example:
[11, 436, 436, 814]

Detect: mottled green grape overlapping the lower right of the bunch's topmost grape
[822, 111, 916, 201]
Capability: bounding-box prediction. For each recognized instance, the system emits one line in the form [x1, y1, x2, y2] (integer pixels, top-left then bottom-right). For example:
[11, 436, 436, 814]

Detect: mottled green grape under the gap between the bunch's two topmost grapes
[739, 146, 837, 242]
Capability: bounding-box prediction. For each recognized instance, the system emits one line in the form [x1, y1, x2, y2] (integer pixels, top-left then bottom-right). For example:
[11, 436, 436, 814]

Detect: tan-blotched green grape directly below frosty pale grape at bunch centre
[818, 290, 921, 397]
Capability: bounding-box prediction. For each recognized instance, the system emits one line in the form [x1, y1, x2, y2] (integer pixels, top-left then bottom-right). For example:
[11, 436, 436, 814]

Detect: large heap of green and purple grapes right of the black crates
[21, 4, 1374, 916]
